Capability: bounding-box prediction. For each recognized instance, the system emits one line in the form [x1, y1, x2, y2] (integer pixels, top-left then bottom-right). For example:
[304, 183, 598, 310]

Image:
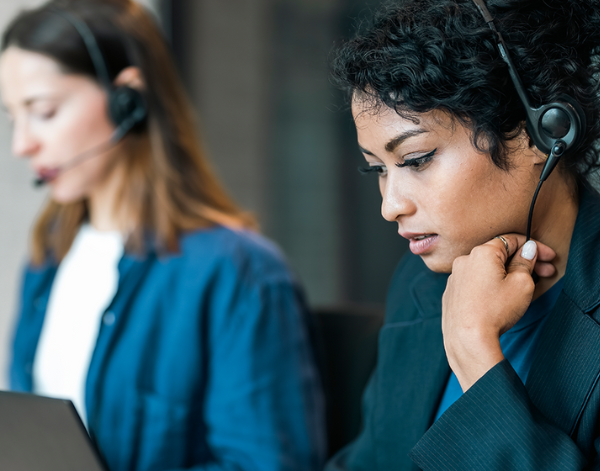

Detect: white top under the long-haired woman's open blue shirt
[33, 224, 123, 423]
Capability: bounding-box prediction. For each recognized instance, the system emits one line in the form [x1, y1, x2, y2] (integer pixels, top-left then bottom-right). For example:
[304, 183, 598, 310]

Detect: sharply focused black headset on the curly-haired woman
[473, 0, 586, 240]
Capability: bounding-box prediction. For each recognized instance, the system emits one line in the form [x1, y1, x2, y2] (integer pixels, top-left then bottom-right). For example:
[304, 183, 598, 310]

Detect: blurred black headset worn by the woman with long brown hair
[34, 7, 148, 186]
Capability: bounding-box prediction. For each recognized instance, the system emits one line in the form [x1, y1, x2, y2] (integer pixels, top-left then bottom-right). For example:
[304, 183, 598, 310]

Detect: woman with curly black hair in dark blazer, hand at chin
[328, 0, 600, 470]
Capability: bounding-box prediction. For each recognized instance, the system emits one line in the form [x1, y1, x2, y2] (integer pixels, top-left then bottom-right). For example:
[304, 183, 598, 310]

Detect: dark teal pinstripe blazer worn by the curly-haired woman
[327, 185, 600, 471]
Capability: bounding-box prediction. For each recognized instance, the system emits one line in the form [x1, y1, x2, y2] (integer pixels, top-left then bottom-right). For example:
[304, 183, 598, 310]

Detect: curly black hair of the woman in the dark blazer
[332, 0, 600, 180]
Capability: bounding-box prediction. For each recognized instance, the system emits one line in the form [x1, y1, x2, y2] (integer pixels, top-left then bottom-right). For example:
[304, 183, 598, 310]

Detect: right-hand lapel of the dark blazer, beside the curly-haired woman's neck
[526, 185, 600, 435]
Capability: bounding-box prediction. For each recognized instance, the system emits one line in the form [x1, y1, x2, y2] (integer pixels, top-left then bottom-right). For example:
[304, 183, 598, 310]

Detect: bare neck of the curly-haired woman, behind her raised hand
[532, 170, 579, 299]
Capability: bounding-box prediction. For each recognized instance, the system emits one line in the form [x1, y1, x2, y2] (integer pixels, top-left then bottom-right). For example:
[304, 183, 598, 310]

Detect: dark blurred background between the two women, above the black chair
[156, 0, 407, 306]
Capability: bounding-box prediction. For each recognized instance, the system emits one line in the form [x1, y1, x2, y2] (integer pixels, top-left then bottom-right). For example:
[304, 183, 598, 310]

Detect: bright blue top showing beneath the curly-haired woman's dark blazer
[435, 279, 563, 421]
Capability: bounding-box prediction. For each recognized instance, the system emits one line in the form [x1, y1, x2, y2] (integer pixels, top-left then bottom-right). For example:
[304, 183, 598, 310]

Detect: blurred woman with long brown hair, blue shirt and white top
[0, 0, 324, 471]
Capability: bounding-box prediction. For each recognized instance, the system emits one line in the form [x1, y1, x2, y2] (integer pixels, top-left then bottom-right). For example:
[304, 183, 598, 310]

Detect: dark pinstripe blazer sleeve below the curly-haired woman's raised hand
[411, 360, 586, 471]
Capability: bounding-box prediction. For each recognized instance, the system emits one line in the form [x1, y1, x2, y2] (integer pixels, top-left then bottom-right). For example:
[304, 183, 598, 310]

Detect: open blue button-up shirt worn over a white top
[10, 227, 325, 471]
